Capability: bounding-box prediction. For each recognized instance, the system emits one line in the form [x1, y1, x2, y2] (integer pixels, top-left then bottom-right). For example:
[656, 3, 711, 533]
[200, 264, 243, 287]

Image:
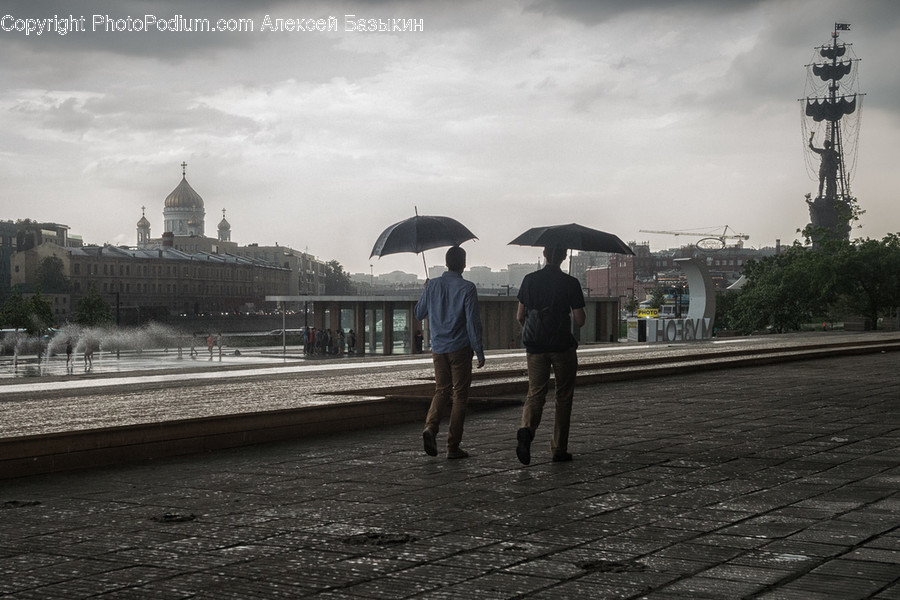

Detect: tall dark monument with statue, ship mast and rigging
[800, 23, 864, 246]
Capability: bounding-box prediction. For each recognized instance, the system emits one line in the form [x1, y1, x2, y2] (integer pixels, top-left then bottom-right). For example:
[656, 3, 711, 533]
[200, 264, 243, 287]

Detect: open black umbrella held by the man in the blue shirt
[369, 211, 478, 277]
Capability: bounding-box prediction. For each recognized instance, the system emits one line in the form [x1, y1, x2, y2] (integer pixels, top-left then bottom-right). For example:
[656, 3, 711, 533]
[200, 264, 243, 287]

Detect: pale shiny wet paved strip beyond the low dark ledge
[0, 332, 900, 439]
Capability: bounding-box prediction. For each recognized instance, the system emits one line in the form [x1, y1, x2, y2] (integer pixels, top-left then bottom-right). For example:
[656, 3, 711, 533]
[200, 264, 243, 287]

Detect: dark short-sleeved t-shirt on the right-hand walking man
[518, 265, 584, 354]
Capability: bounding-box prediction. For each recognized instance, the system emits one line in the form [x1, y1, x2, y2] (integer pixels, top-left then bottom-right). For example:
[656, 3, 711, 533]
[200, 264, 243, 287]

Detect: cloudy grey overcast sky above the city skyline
[0, 0, 900, 274]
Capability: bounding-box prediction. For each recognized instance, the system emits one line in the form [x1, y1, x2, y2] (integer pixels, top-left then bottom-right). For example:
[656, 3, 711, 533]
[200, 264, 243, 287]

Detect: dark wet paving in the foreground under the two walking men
[0, 336, 900, 600]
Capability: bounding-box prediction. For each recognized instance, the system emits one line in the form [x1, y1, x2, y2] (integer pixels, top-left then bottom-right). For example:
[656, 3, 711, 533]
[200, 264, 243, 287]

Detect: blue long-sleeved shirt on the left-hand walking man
[415, 271, 484, 360]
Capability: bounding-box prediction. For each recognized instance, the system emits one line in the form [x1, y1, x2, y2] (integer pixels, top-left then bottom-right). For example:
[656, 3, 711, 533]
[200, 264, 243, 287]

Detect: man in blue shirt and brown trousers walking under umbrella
[415, 246, 484, 458]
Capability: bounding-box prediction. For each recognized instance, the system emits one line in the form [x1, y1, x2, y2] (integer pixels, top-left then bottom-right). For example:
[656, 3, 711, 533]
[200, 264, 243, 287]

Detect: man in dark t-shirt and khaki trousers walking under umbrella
[516, 247, 585, 465]
